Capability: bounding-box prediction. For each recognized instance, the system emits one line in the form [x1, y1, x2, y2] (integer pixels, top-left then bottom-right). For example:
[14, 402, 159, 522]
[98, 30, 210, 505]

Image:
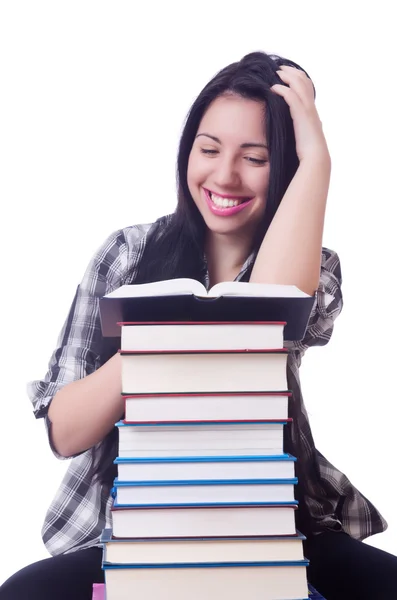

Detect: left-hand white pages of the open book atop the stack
[105, 278, 207, 298]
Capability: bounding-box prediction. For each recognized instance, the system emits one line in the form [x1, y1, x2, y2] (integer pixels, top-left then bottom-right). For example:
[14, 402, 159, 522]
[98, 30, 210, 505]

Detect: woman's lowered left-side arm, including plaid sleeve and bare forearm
[28, 226, 145, 458]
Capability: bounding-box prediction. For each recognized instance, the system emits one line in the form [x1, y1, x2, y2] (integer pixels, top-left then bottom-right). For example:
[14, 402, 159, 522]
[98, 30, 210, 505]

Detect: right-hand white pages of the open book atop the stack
[208, 281, 310, 298]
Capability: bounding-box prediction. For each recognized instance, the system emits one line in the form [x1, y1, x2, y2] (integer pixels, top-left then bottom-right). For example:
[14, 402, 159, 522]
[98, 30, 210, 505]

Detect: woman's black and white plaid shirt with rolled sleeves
[28, 216, 387, 555]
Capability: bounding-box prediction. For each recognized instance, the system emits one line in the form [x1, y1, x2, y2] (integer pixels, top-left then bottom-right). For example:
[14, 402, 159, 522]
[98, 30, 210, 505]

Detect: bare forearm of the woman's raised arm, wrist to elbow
[250, 153, 331, 294]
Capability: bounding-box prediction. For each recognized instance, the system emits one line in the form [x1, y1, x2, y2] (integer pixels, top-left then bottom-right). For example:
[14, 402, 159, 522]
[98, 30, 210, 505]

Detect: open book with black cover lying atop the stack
[99, 278, 314, 340]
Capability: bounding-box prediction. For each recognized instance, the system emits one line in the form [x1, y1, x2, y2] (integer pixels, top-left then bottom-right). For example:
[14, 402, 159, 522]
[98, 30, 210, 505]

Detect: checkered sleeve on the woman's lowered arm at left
[27, 230, 126, 459]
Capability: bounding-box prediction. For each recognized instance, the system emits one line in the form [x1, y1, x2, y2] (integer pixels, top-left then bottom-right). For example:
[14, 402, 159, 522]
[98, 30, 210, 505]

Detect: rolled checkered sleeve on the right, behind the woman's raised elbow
[293, 248, 343, 353]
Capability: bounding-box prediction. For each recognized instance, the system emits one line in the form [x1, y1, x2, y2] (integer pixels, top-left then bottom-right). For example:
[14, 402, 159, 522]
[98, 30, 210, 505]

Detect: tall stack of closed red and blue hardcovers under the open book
[97, 284, 324, 600]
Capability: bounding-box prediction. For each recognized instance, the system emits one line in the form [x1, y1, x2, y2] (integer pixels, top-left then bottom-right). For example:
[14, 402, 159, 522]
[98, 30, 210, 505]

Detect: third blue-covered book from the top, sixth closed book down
[114, 478, 296, 505]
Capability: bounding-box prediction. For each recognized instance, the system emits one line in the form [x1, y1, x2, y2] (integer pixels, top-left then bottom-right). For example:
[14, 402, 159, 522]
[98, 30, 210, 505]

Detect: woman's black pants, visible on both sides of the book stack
[0, 531, 397, 600]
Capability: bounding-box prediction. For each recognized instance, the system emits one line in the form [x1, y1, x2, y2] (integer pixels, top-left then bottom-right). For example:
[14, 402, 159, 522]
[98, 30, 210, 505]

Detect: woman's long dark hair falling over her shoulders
[93, 52, 316, 529]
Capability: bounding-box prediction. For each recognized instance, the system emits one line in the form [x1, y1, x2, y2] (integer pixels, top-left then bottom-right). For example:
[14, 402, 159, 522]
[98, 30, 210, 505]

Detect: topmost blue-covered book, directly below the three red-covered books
[116, 422, 284, 458]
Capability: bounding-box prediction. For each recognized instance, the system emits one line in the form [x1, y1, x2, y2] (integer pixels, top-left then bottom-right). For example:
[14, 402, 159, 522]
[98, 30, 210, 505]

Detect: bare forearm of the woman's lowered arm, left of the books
[48, 354, 124, 457]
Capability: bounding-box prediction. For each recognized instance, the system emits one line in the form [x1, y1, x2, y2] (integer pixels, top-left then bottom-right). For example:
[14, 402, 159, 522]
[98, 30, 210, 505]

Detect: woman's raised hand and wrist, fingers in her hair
[271, 65, 330, 162]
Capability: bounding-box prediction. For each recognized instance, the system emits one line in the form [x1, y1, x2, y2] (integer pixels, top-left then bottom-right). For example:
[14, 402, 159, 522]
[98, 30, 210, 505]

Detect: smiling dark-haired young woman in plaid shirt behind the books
[0, 52, 397, 600]
